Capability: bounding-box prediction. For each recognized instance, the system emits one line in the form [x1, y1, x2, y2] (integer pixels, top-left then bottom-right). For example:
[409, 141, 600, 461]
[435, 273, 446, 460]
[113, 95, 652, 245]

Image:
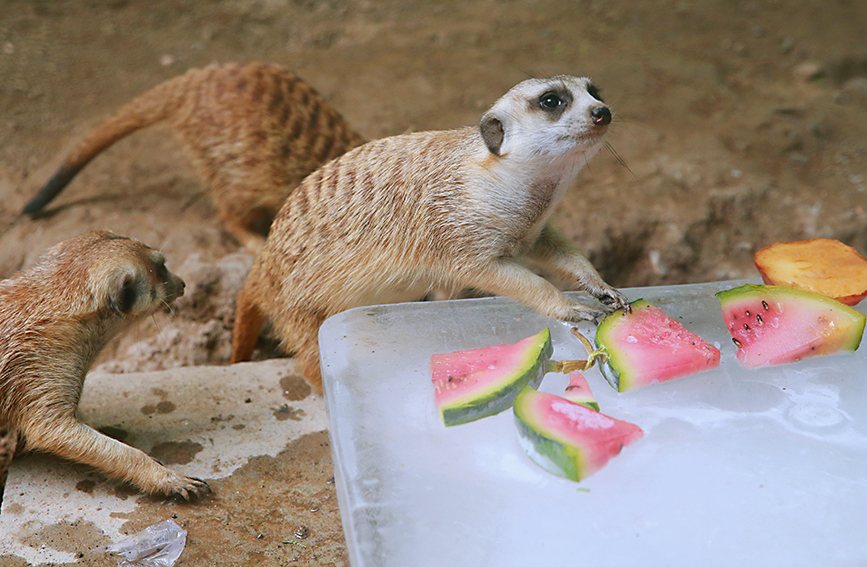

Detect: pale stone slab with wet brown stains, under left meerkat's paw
[0, 359, 339, 565]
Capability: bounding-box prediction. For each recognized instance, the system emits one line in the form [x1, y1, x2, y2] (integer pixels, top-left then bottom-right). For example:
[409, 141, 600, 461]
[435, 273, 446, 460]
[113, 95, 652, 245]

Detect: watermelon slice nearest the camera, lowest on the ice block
[515, 386, 644, 481]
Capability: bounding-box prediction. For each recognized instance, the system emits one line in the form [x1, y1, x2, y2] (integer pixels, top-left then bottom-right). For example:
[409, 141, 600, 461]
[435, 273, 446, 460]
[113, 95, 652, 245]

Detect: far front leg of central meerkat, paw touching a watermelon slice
[523, 225, 629, 311]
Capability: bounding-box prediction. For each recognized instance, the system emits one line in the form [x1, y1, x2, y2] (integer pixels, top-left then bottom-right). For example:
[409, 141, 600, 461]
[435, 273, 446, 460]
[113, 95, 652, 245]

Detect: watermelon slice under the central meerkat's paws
[596, 299, 720, 392]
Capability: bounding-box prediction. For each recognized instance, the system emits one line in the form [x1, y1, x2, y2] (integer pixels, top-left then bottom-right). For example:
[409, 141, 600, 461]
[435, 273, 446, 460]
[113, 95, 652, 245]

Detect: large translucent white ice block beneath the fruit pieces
[320, 282, 867, 567]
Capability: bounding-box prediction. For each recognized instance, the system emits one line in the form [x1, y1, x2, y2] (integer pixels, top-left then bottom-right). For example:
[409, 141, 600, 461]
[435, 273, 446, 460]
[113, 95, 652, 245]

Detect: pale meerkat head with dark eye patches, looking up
[479, 75, 611, 159]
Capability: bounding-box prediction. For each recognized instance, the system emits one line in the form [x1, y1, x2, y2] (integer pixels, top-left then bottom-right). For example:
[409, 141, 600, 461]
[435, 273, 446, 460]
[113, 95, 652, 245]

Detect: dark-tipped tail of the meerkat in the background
[21, 73, 190, 215]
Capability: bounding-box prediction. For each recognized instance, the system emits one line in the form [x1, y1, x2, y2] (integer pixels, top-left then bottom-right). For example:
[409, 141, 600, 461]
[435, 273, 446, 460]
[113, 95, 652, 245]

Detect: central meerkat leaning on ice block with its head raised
[231, 75, 628, 391]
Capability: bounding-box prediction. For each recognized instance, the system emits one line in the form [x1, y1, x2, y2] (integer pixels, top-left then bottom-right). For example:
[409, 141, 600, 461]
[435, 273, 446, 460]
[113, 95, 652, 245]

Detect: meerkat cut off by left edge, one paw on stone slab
[0, 231, 210, 500]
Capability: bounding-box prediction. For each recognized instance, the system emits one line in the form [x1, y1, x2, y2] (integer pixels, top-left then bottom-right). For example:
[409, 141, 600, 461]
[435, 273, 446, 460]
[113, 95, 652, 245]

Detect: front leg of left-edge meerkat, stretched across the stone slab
[24, 415, 211, 500]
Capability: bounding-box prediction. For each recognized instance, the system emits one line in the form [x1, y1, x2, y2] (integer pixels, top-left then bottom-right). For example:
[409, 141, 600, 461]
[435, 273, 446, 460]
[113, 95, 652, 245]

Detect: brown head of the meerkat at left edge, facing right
[39, 231, 184, 319]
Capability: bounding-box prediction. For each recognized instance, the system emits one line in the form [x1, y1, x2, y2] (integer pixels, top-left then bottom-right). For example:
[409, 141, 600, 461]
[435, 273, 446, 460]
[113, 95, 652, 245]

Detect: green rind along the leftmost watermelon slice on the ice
[440, 328, 554, 427]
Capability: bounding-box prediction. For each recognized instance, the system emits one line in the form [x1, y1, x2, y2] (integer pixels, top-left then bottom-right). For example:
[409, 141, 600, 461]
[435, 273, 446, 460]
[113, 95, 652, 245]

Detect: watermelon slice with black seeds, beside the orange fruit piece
[716, 284, 865, 368]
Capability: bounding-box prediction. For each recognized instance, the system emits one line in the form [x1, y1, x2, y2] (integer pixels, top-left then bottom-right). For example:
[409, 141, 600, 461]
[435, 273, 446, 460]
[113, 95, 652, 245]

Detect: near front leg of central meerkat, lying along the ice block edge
[461, 258, 605, 321]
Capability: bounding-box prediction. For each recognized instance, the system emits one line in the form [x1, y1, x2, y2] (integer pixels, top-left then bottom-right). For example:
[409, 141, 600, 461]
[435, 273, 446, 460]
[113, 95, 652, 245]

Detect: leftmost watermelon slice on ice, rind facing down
[431, 329, 554, 426]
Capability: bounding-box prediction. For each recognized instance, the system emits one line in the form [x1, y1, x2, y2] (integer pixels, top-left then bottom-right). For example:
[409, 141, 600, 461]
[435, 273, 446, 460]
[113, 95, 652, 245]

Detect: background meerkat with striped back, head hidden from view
[22, 63, 365, 253]
